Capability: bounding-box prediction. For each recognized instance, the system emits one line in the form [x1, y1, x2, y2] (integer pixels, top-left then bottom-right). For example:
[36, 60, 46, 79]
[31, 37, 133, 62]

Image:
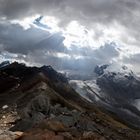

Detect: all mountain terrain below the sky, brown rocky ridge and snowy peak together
[0, 61, 140, 140]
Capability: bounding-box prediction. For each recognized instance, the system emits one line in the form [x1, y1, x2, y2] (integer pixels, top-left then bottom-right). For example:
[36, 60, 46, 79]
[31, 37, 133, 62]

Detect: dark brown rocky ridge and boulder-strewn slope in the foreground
[0, 63, 140, 140]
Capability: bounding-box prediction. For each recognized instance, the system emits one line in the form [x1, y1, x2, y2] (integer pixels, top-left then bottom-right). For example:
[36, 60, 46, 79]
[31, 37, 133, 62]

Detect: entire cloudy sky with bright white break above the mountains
[0, 0, 140, 73]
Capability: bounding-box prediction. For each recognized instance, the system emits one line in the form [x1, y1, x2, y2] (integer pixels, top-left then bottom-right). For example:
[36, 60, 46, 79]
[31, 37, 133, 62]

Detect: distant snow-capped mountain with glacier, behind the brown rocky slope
[71, 65, 140, 128]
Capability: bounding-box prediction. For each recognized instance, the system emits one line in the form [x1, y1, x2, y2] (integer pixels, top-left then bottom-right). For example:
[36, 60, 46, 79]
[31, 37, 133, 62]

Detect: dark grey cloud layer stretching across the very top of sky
[0, 0, 140, 24]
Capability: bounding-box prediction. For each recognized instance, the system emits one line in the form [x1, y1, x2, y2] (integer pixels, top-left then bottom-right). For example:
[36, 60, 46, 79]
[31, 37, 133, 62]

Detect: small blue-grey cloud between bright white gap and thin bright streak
[65, 42, 119, 60]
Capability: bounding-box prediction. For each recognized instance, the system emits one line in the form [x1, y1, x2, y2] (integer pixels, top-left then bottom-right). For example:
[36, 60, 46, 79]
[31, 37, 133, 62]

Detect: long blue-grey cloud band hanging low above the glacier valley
[25, 40, 119, 73]
